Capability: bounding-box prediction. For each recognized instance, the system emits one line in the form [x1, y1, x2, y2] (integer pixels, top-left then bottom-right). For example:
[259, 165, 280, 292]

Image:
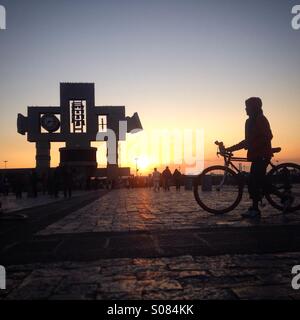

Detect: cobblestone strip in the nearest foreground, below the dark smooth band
[0, 253, 300, 300]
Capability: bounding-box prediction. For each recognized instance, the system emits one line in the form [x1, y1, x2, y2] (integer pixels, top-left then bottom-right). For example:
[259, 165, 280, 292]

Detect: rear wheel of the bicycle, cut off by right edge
[266, 163, 300, 212]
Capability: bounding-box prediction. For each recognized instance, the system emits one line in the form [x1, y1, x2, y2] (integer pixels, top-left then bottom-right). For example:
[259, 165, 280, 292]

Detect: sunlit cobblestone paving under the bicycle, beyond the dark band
[39, 189, 300, 235]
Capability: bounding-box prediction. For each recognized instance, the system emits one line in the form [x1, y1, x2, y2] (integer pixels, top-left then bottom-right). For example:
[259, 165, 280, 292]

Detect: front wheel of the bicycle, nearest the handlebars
[194, 166, 244, 214]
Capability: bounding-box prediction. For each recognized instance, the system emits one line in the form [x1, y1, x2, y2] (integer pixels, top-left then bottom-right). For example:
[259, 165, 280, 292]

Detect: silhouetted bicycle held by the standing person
[194, 141, 300, 214]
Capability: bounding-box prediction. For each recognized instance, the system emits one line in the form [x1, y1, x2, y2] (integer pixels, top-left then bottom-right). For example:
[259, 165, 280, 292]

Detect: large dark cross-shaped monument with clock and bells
[17, 83, 142, 175]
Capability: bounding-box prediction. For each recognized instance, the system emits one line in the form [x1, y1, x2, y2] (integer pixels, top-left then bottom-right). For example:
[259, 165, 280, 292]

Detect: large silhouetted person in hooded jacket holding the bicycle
[226, 97, 273, 218]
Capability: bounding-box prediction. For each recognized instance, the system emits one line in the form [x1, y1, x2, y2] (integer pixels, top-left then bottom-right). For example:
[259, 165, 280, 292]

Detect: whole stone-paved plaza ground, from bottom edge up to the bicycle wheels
[0, 188, 300, 300]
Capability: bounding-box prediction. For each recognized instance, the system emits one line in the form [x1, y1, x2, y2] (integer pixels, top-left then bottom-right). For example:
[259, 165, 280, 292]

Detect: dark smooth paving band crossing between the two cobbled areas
[1, 225, 300, 266]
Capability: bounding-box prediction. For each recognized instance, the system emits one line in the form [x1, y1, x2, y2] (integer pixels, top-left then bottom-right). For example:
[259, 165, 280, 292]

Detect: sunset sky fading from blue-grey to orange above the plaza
[0, 0, 300, 173]
